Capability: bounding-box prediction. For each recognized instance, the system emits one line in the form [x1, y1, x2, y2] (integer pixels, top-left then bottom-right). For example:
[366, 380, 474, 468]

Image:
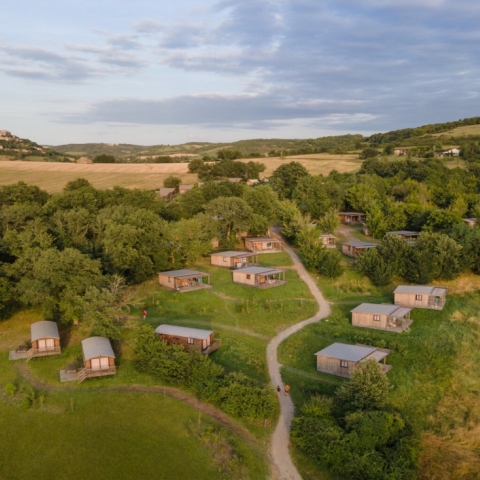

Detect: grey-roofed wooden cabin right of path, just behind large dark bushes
[315, 343, 392, 378]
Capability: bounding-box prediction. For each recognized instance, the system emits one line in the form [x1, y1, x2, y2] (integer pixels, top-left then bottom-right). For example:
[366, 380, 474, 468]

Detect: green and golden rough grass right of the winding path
[279, 269, 480, 478]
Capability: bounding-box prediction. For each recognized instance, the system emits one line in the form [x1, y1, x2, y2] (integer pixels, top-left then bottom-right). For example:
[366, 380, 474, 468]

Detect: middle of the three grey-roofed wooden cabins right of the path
[350, 303, 413, 333]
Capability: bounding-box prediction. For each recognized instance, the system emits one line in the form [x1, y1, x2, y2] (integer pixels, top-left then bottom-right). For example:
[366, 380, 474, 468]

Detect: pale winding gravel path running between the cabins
[267, 230, 330, 480]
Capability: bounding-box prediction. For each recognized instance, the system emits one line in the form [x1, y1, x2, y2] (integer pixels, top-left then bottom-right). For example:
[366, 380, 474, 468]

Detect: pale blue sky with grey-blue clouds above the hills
[0, 0, 480, 145]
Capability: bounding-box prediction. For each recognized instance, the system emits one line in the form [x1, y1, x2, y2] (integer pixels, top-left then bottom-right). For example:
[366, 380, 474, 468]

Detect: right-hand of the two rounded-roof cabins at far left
[77, 337, 116, 383]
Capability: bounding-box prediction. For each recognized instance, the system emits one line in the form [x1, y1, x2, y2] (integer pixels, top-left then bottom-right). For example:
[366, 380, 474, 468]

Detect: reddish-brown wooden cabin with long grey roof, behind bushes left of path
[155, 324, 222, 355]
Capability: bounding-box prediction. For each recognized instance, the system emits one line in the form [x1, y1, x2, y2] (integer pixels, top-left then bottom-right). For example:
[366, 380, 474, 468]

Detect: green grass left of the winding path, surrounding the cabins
[0, 253, 317, 479]
